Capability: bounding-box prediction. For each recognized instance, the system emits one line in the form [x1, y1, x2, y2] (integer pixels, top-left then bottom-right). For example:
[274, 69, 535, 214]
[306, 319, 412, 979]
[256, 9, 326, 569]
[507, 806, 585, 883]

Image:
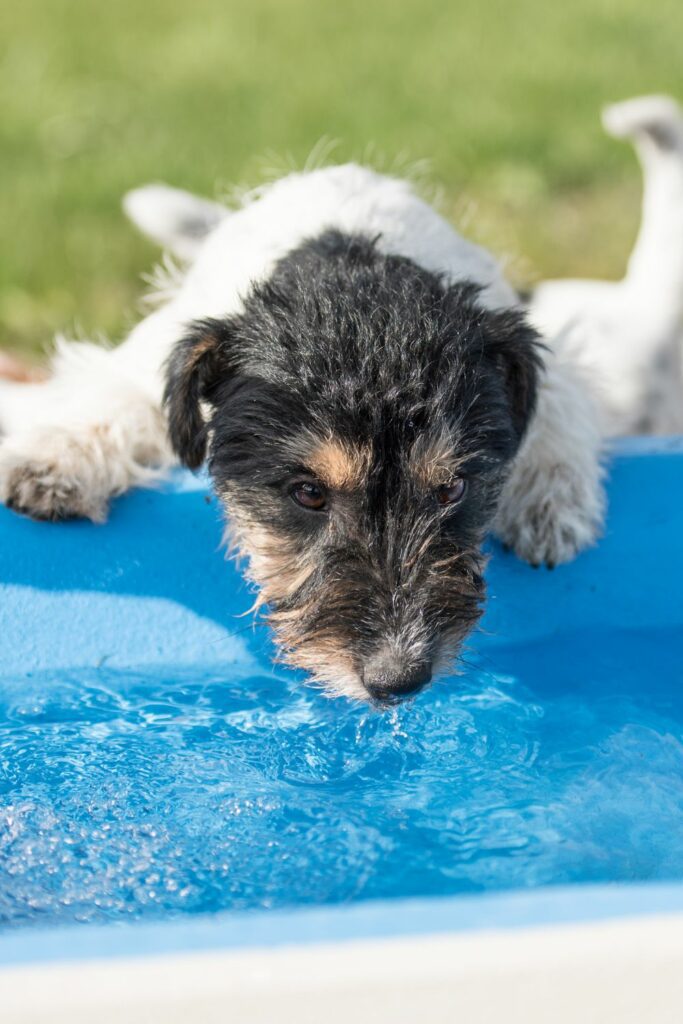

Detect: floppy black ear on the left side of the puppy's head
[164, 319, 232, 469]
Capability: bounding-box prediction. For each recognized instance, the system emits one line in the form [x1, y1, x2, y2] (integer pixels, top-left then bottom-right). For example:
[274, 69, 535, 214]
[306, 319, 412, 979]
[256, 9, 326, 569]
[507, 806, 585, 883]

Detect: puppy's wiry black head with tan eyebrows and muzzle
[166, 231, 539, 702]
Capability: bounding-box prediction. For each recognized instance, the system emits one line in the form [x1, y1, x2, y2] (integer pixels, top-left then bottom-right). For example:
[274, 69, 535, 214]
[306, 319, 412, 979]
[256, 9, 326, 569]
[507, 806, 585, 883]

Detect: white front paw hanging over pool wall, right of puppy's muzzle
[495, 464, 604, 568]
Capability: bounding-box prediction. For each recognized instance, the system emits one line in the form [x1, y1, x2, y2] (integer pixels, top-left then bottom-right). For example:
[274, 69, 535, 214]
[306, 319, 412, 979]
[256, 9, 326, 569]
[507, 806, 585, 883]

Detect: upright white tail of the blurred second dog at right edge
[602, 96, 683, 296]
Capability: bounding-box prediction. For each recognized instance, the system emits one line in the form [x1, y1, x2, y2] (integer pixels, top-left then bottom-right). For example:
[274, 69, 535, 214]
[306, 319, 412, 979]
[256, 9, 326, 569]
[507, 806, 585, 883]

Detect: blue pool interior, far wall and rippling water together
[0, 440, 683, 950]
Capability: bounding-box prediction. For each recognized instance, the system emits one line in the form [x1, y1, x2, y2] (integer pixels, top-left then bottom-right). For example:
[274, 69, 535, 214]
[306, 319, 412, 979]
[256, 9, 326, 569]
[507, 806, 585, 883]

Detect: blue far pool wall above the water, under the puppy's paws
[0, 438, 683, 678]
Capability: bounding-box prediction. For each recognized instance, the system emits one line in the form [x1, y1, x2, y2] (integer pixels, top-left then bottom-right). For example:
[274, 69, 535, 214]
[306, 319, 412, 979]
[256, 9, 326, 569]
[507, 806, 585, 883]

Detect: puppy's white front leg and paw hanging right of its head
[495, 352, 605, 567]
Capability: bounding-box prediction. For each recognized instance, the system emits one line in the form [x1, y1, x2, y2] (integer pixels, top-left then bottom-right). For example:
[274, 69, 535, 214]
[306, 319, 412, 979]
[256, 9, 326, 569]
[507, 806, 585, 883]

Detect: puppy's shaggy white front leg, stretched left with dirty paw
[0, 317, 174, 522]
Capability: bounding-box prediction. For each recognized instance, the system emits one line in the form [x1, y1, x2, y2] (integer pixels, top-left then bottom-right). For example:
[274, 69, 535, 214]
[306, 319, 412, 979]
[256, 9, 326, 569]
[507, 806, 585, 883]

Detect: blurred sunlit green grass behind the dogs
[0, 0, 683, 354]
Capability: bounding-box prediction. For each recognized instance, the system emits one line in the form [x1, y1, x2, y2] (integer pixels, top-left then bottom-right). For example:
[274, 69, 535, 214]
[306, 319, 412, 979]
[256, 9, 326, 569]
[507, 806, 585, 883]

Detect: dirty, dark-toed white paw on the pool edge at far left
[0, 431, 108, 522]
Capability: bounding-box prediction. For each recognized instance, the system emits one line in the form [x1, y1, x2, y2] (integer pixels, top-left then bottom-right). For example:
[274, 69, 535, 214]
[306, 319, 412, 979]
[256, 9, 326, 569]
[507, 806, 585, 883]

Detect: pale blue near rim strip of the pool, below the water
[0, 882, 683, 968]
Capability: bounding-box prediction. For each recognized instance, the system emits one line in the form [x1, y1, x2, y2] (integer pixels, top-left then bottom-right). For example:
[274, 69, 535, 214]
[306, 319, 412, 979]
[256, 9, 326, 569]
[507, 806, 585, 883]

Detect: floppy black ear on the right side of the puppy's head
[486, 309, 544, 440]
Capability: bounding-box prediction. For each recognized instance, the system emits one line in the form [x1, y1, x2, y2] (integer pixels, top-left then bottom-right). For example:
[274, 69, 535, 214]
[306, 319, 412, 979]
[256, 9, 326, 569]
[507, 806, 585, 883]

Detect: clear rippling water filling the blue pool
[0, 631, 683, 928]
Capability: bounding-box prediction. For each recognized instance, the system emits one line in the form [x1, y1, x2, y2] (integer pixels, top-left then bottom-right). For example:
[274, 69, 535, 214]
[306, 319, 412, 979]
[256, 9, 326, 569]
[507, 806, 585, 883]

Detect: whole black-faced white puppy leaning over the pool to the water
[0, 164, 604, 706]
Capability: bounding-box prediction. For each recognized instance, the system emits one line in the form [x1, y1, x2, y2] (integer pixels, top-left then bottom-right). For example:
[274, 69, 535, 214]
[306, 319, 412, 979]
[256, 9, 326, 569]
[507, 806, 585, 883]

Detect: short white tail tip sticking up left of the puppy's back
[123, 184, 228, 261]
